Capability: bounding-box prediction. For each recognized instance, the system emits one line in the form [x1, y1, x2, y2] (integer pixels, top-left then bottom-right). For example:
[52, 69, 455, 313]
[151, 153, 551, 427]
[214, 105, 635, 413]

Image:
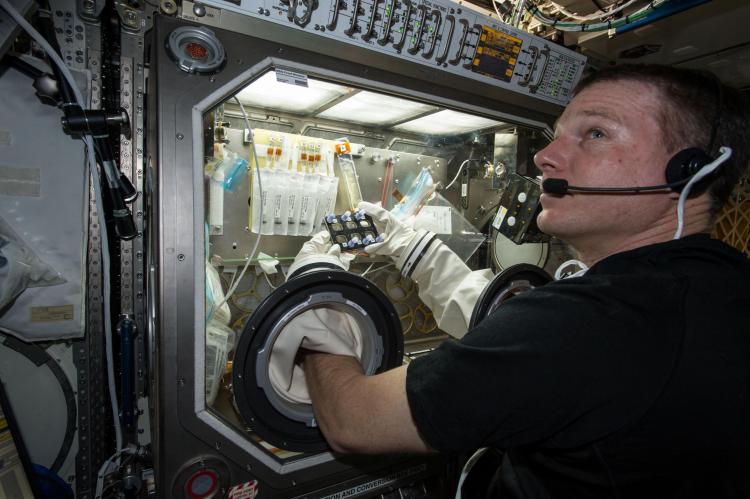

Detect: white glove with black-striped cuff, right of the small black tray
[357, 201, 493, 338]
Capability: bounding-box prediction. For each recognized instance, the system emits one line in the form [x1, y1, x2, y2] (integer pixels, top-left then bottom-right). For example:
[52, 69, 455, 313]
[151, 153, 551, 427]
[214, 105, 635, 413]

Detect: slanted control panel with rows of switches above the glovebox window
[181, 0, 586, 105]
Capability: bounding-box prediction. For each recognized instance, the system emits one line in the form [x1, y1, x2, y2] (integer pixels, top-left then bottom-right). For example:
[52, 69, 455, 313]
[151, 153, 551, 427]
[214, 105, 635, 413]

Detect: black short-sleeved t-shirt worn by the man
[406, 235, 750, 498]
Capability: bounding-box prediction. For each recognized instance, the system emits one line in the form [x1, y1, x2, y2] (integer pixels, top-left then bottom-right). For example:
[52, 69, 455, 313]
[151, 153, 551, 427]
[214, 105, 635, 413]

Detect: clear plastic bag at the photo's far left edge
[0, 217, 66, 315]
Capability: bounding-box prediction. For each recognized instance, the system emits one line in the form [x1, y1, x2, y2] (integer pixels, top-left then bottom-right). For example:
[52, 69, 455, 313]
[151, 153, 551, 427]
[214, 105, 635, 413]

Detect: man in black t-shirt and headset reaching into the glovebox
[295, 65, 750, 498]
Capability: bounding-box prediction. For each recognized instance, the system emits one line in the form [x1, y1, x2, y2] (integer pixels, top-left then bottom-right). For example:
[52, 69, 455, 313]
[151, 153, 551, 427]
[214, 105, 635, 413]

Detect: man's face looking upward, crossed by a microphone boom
[534, 80, 674, 250]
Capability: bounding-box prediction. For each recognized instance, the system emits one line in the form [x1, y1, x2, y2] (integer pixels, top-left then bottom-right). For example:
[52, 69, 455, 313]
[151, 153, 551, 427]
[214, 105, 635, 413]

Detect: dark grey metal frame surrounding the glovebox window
[149, 13, 559, 497]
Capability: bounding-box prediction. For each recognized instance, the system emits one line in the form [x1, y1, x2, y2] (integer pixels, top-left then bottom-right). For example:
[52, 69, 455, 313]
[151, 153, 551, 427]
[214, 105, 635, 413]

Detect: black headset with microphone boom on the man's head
[542, 73, 732, 196]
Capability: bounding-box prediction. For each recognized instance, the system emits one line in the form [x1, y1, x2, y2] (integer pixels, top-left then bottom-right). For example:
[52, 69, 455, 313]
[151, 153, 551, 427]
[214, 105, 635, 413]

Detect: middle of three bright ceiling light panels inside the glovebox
[318, 91, 437, 126]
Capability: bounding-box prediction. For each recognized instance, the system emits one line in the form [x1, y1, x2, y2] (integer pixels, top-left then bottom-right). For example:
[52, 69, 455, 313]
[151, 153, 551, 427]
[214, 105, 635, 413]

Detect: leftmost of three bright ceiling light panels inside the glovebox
[237, 71, 353, 114]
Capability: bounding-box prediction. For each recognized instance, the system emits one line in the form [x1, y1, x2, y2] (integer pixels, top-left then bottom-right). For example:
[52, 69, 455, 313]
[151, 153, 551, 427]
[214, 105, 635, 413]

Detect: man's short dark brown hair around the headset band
[573, 64, 750, 216]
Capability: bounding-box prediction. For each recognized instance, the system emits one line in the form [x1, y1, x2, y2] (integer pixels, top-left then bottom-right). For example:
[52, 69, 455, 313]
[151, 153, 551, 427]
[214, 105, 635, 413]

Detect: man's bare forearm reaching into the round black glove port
[303, 352, 431, 454]
